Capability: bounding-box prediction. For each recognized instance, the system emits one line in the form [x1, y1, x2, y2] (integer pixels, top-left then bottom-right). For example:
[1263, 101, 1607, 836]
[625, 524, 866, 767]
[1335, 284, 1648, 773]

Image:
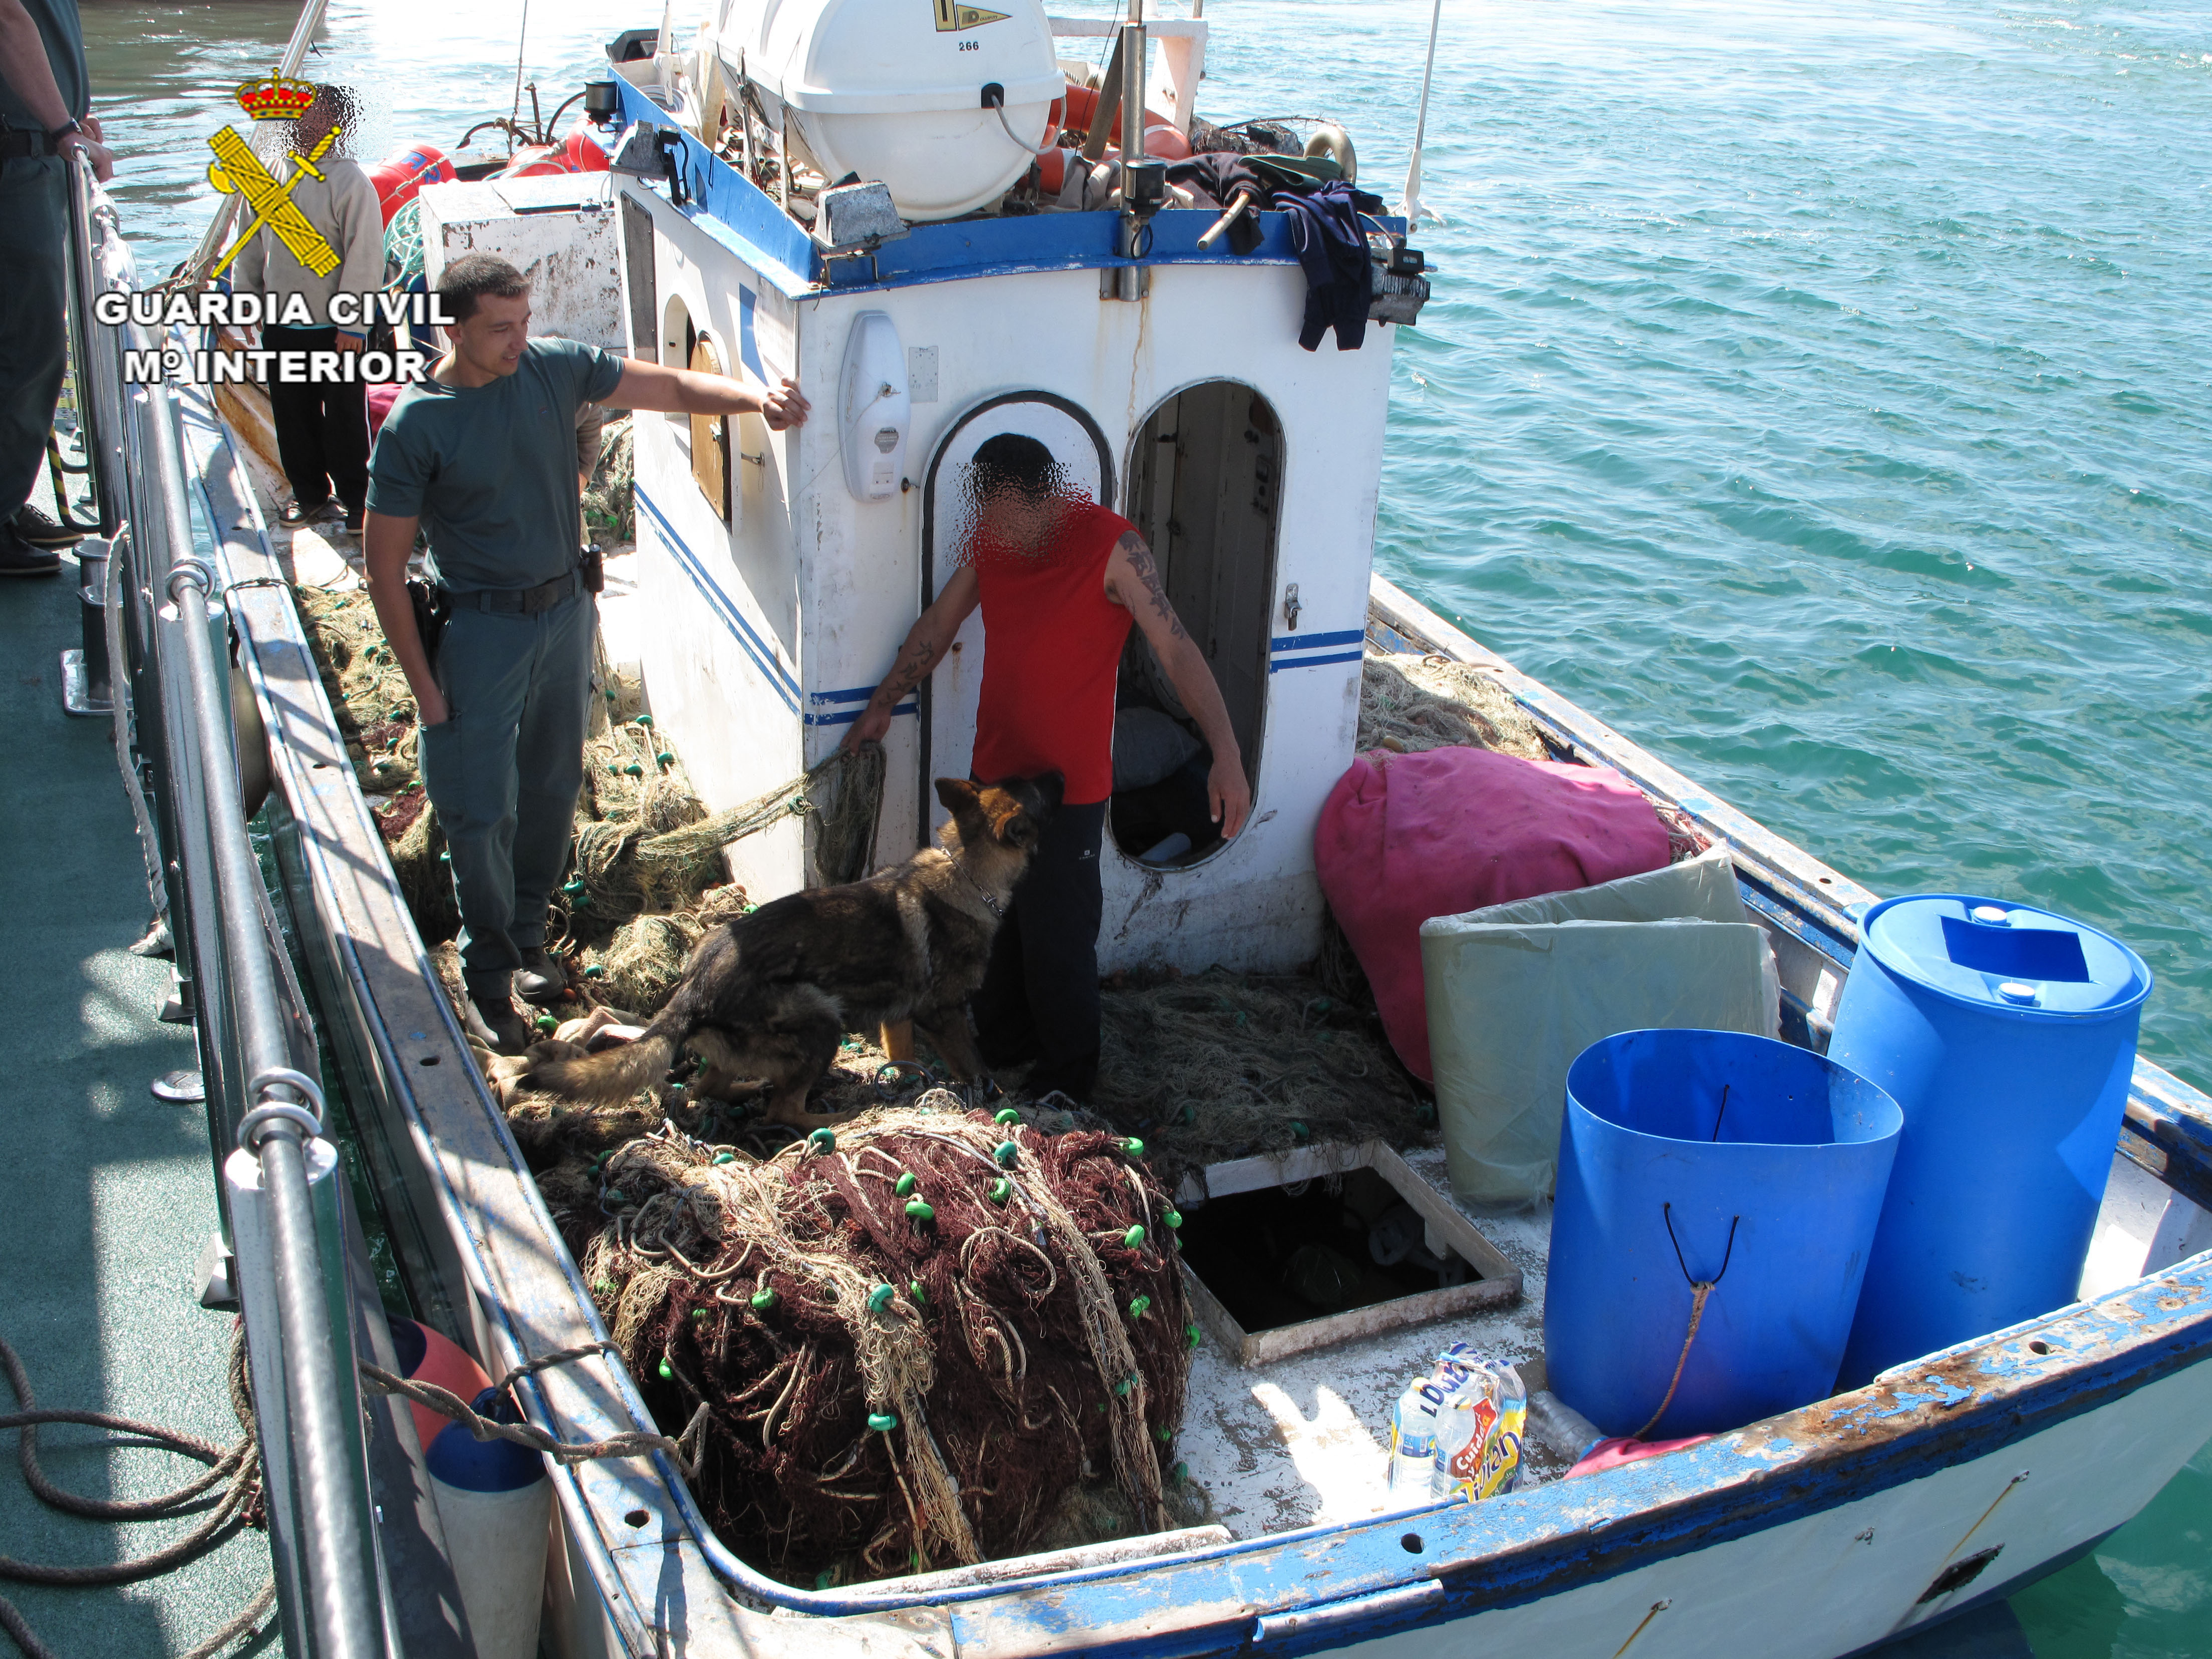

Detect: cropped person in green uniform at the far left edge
[0, 0, 115, 575]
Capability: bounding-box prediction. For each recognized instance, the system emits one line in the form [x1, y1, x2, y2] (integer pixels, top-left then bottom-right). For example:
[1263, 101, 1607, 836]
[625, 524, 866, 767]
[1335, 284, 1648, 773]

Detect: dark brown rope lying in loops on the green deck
[0, 1327, 276, 1659]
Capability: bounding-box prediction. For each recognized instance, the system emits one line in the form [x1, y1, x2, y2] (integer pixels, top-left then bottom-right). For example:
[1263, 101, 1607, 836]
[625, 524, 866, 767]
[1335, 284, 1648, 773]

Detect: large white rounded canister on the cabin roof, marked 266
[719, 0, 1066, 221]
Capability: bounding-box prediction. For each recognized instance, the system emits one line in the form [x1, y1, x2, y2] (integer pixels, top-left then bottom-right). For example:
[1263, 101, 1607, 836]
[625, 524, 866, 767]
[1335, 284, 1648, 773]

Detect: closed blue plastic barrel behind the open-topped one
[1827, 894, 2150, 1387]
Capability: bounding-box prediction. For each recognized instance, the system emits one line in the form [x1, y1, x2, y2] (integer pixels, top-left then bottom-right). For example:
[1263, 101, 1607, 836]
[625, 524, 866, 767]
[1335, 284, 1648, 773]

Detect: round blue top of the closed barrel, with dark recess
[1862, 894, 2150, 1017]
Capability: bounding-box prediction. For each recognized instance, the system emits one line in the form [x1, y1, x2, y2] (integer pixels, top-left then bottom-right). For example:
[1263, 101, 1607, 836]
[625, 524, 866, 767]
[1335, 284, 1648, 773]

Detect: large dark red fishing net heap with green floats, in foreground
[542, 1106, 1190, 1584]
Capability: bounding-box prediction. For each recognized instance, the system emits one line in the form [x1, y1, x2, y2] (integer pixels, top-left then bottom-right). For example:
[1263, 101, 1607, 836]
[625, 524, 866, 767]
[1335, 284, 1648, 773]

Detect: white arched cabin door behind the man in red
[922, 392, 1115, 832]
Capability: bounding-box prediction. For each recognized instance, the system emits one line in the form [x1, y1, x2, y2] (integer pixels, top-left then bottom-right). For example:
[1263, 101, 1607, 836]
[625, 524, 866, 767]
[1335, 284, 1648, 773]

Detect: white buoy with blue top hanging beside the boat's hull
[425, 1389, 553, 1659]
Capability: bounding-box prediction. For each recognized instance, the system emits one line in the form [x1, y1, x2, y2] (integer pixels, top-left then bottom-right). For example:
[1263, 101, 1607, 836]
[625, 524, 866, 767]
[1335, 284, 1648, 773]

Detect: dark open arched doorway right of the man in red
[1108, 381, 1283, 869]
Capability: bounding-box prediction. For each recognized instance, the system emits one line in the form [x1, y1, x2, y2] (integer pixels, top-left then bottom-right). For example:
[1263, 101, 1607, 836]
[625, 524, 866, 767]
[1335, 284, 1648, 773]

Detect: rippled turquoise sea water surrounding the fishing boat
[86, 0, 2212, 1659]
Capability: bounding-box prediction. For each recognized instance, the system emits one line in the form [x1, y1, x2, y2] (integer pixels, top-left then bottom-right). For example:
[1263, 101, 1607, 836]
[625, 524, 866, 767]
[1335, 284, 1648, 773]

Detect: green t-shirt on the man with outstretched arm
[369, 339, 622, 593]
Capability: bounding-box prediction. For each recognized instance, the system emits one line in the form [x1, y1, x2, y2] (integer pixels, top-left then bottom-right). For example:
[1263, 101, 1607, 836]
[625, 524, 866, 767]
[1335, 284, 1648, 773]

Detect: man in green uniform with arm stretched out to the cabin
[363, 254, 807, 1053]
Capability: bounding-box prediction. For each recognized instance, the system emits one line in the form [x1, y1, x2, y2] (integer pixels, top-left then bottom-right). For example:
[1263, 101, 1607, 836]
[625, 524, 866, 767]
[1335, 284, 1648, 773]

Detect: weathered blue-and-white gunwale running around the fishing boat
[172, 341, 2212, 1650]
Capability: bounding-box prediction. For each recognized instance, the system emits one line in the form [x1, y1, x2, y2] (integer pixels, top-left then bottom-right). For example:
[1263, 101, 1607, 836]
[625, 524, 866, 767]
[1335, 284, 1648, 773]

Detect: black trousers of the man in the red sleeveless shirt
[969, 801, 1106, 1099]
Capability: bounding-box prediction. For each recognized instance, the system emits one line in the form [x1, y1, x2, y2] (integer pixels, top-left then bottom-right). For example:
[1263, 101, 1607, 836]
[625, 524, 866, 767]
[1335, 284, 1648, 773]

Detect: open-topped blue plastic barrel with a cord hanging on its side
[1544, 1031, 1902, 1440]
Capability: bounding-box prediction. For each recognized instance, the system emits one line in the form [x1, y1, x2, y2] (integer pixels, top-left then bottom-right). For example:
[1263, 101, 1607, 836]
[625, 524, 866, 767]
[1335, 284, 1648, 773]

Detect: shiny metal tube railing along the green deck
[71, 157, 396, 1659]
